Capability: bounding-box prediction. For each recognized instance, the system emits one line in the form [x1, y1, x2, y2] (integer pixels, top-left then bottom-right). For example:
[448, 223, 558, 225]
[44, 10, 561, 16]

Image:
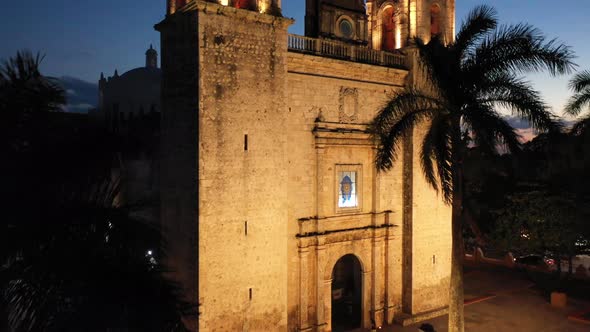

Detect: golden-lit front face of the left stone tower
[199, 7, 290, 331]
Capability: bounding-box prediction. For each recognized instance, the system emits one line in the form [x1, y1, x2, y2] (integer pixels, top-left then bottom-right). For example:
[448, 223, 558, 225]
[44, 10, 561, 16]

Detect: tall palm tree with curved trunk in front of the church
[372, 6, 574, 332]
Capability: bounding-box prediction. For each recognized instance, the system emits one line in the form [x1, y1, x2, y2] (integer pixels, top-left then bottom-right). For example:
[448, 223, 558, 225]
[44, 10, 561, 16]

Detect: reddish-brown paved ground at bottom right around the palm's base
[381, 269, 590, 332]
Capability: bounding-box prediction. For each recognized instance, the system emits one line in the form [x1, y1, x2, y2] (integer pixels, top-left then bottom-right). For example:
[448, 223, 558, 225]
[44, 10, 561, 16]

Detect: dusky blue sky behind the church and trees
[0, 0, 590, 113]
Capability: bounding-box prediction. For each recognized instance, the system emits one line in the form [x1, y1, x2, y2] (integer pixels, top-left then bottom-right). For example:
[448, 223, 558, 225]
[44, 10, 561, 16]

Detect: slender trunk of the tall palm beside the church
[449, 131, 465, 332]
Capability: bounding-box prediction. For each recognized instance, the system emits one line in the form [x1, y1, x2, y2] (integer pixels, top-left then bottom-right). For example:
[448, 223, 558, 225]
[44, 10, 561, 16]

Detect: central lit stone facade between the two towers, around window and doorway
[287, 53, 406, 328]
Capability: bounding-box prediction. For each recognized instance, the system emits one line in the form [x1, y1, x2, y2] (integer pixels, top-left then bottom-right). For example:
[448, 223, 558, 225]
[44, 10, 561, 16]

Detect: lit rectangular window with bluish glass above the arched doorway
[335, 165, 361, 212]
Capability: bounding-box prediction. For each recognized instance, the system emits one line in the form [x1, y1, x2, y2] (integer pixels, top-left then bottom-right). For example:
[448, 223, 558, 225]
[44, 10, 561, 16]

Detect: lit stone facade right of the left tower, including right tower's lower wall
[287, 53, 450, 329]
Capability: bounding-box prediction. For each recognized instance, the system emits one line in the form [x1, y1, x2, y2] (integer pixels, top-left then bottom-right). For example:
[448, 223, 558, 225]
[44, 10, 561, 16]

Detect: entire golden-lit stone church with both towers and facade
[156, 0, 455, 331]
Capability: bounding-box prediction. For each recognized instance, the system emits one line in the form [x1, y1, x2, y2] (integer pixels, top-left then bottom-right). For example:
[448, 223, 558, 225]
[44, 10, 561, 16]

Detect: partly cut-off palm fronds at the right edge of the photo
[565, 70, 590, 136]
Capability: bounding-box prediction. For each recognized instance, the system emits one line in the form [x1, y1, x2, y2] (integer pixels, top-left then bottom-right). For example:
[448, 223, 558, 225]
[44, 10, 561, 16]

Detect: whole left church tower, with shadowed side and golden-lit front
[156, 0, 292, 331]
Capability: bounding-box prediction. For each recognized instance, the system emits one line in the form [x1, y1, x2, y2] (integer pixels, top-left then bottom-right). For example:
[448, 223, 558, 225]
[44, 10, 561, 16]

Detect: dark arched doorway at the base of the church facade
[332, 254, 363, 331]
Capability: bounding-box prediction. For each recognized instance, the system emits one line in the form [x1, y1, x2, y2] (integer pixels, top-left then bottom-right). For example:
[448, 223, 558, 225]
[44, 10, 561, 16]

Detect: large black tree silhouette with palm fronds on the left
[0, 52, 196, 332]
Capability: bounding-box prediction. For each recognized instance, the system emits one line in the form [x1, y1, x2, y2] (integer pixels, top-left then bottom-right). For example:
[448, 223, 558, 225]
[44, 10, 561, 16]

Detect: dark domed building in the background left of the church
[96, 45, 162, 223]
